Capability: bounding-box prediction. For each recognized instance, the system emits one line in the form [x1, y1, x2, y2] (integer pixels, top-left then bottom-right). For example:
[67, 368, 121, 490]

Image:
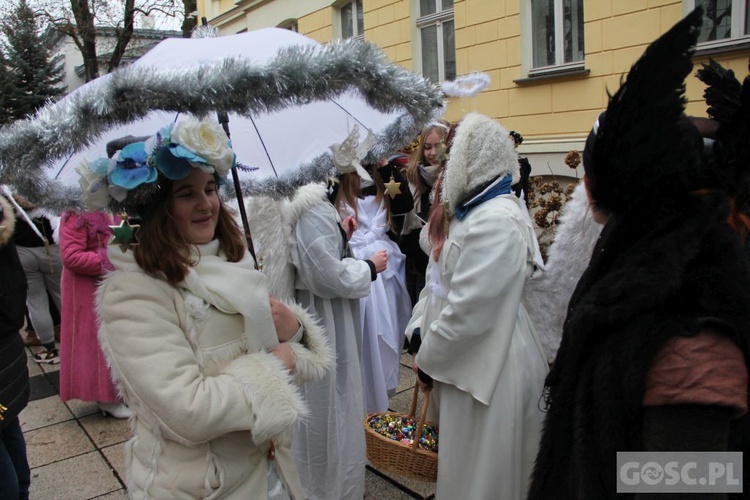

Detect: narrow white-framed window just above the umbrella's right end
[417, 0, 456, 82]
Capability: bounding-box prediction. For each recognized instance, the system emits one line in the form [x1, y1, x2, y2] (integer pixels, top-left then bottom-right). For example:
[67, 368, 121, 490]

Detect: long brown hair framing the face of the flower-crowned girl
[133, 182, 245, 285]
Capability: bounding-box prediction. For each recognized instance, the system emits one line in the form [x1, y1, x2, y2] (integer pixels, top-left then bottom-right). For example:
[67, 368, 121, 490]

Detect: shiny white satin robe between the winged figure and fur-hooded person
[341, 196, 411, 413]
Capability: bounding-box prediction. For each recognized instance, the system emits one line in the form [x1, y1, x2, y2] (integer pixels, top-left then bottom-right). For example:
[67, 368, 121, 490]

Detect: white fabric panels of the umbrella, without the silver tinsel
[47, 28, 432, 186]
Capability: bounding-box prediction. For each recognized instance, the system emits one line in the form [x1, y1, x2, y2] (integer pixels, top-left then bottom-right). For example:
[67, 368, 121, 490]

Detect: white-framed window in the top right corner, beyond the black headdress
[688, 0, 750, 45]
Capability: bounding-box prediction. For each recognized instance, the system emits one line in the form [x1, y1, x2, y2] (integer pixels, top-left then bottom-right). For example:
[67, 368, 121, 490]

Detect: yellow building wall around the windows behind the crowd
[198, 0, 748, 175]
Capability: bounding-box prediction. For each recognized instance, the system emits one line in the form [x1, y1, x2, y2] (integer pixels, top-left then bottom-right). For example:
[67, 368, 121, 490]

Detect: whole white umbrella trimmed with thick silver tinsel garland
[0, 28, 443, 219]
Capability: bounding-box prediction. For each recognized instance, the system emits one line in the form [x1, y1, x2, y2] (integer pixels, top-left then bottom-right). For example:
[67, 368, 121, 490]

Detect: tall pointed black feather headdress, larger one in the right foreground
[584, 7, 703, 214]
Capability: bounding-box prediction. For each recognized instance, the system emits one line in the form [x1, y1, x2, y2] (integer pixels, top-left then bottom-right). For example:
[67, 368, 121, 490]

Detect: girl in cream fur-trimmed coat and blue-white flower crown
[89, 119, 332, 499]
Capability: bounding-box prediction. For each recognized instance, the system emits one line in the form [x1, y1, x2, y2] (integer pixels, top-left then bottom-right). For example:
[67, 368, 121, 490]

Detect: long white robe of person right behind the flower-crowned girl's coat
[288, 192, 371, 500]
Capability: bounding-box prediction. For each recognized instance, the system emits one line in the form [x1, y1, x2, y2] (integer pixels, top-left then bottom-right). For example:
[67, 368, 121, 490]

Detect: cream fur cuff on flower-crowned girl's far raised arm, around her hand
[286, 303, 335, 383]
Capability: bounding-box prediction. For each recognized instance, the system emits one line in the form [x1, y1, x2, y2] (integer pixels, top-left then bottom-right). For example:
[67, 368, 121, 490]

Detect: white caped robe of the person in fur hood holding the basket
[407, 195, 547, 500]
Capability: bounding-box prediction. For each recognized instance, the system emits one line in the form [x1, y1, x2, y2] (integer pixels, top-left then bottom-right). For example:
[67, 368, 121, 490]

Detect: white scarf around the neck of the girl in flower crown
[178, 240, 279, 352]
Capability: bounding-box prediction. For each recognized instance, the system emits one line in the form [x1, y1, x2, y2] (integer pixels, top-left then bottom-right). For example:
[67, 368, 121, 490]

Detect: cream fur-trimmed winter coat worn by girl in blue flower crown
[97, 241, 332, 500]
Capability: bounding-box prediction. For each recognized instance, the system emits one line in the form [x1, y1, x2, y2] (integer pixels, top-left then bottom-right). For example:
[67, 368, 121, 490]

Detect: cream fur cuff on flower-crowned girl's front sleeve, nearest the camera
[224, 352, 308, 445]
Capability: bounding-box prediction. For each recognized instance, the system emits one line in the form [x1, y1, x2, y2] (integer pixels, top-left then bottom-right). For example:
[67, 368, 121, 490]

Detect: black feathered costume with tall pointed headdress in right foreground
[529, 8, 750, 500]
